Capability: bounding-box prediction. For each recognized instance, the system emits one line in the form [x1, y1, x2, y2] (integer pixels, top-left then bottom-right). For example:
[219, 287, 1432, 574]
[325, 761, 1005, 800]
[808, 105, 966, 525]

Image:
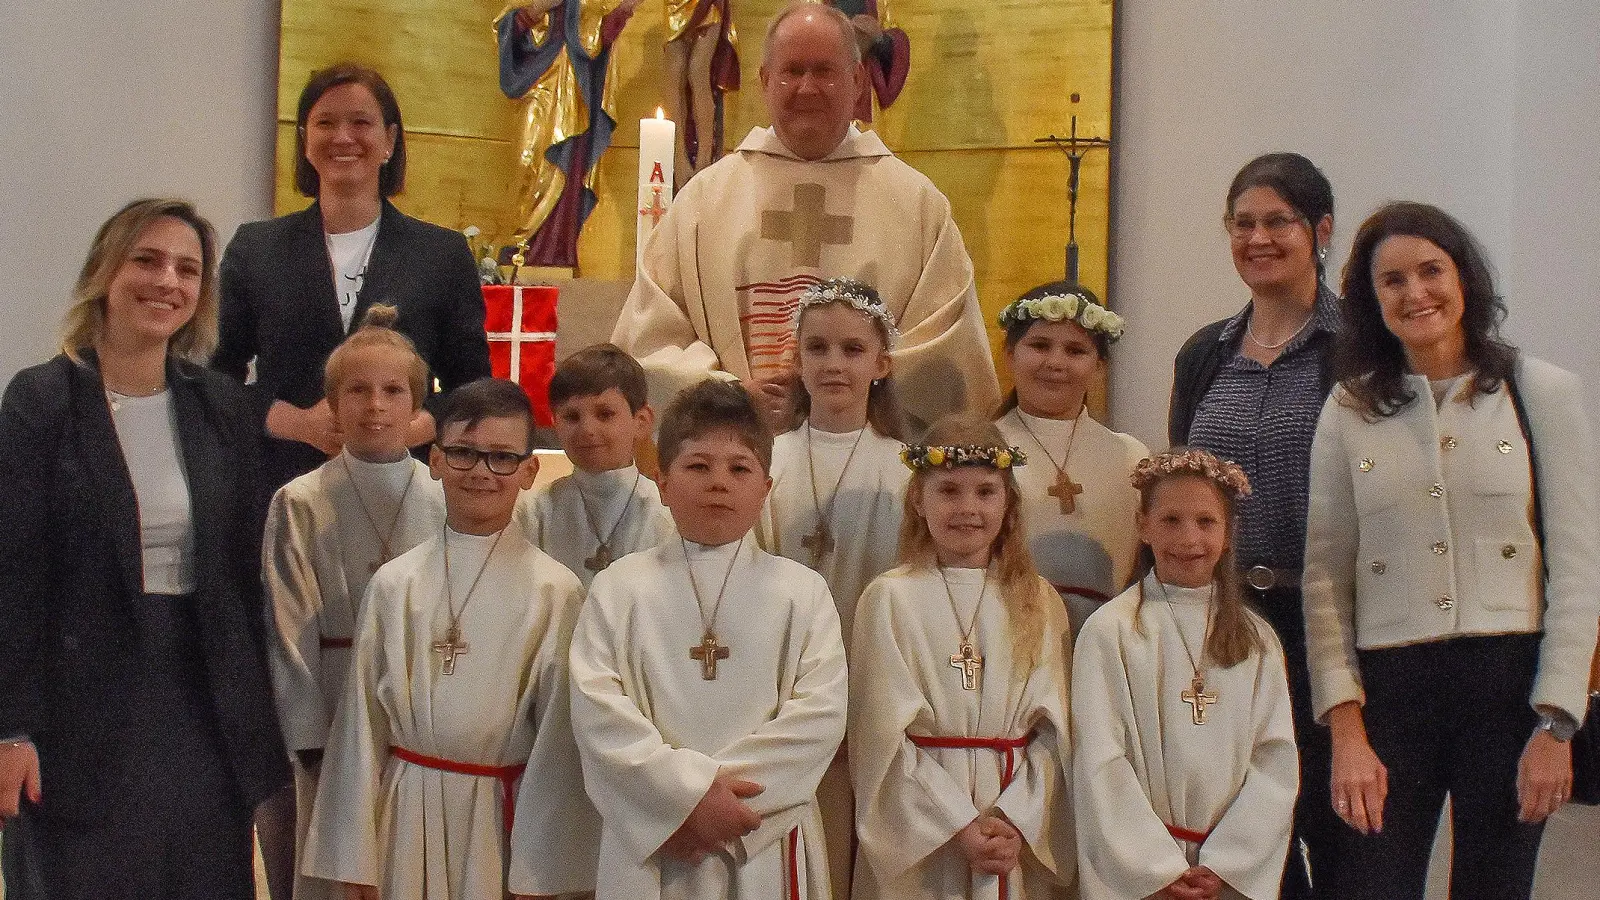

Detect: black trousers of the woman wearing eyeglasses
[1243, 586, 1346, 900]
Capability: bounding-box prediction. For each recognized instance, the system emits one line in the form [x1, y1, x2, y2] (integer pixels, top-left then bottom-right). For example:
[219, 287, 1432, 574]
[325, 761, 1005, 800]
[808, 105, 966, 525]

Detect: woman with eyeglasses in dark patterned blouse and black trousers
[1168, 154, 1342, 900]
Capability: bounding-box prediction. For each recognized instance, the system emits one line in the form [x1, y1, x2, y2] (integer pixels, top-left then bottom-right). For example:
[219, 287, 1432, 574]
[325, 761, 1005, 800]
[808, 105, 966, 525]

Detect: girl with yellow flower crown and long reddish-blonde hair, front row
[845, 415, 1077, 900]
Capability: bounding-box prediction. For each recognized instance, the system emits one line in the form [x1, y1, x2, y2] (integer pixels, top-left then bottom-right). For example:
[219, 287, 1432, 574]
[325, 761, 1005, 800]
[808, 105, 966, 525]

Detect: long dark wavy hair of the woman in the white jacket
[1333, 202, 1517, 418]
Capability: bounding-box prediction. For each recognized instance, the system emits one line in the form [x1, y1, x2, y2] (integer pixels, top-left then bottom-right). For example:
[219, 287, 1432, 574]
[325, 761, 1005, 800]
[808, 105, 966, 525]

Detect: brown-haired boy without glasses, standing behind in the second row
[517, 344, 674, 589]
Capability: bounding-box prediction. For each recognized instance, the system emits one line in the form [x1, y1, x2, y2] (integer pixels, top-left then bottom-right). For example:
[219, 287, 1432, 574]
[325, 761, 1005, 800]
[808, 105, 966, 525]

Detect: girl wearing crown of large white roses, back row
[995, 282, 1149, 634]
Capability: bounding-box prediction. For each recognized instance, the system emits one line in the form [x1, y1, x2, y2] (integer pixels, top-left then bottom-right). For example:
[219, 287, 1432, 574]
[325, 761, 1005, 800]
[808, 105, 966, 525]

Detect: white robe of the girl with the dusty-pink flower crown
[1072, 573, 1299, 900]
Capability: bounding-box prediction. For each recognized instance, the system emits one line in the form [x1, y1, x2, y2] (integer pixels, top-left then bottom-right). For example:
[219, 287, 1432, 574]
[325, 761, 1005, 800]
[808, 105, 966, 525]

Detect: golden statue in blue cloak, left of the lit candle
[494, 0, 638, 269]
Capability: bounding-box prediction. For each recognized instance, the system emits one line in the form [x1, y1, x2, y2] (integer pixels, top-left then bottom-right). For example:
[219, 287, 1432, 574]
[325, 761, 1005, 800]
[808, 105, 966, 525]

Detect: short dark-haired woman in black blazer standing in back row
[211, 64, 490, 496]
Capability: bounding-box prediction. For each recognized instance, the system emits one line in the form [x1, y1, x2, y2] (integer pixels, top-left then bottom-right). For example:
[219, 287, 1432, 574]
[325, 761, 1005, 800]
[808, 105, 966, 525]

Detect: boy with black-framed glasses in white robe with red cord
[306, 380, 598, 900]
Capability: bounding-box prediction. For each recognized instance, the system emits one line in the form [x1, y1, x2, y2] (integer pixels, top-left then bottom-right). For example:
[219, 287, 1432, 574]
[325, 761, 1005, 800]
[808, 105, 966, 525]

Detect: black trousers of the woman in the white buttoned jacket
[1334, 634, 1544, 900]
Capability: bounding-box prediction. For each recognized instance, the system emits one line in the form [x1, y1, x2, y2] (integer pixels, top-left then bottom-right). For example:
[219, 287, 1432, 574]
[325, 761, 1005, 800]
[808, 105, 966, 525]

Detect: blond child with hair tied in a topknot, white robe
[261, 306, 445, 900]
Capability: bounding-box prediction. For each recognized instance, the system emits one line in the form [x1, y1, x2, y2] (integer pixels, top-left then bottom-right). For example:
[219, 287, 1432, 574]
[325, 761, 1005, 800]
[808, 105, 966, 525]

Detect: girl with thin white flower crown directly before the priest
[757, 279, 909, 900]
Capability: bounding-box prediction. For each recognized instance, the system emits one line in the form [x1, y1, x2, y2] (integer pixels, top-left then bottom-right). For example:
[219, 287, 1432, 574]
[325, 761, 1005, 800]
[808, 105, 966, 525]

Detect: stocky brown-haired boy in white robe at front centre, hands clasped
[571, 381, 846, 900]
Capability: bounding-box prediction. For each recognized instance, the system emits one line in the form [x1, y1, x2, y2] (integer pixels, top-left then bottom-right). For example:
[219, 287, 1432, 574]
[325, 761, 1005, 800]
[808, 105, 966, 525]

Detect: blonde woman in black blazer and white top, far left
[0, 200, 288, 900]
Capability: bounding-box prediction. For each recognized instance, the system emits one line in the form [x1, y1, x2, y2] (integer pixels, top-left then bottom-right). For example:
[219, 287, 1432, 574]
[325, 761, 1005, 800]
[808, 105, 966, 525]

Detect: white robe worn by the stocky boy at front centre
[571, 533, 846, 900]
